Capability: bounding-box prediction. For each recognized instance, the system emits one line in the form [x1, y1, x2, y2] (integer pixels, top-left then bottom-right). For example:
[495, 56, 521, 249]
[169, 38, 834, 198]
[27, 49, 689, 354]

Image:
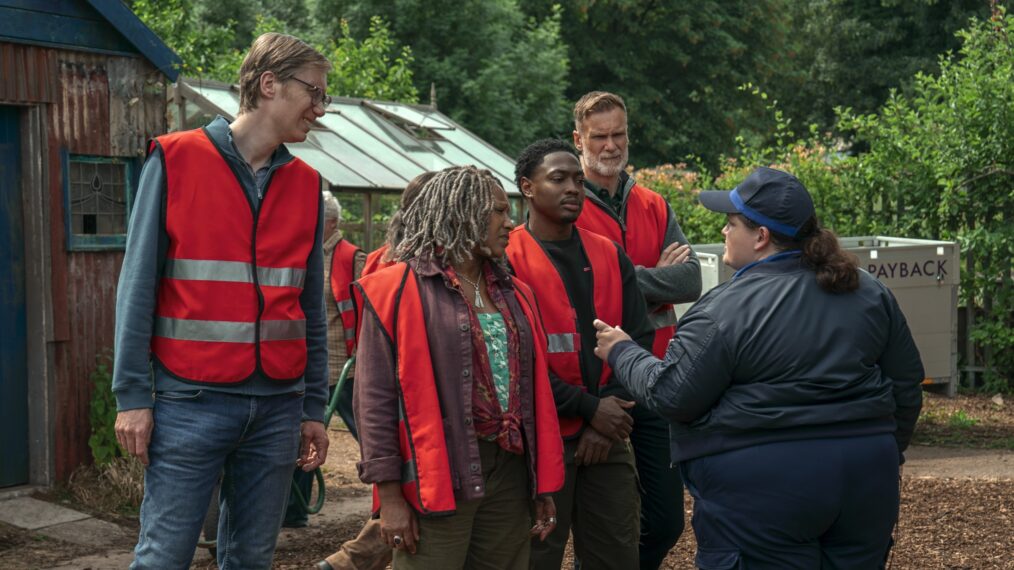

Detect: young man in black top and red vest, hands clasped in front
[507, 139, 654, 570]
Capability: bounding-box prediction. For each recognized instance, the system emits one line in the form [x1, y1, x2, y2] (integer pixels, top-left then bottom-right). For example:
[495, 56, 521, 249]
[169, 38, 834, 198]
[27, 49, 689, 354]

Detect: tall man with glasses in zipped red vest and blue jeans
[113, 33, 331, 569]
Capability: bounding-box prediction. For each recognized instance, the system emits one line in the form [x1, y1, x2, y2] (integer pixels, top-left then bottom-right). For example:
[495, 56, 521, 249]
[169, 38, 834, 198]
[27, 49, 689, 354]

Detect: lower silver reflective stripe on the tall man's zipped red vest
[155, 316, 306, 343]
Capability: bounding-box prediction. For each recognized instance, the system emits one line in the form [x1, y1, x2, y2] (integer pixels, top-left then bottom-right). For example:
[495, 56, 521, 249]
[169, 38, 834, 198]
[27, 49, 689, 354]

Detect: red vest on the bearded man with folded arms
[575, 184, 675, 358]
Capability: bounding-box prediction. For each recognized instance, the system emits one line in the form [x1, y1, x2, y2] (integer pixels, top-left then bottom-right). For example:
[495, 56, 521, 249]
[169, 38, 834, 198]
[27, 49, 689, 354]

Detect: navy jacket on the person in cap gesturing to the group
[608, 253, 924, 461]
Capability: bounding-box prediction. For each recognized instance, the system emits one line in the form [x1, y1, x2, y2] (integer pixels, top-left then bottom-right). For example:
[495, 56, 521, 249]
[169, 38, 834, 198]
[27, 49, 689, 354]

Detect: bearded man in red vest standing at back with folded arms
[574, 91, 701, 570]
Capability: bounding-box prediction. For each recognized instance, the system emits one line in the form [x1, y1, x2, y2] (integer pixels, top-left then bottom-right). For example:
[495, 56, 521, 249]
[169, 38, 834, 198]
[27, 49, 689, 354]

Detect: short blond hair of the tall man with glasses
[239, 31, 331, 114]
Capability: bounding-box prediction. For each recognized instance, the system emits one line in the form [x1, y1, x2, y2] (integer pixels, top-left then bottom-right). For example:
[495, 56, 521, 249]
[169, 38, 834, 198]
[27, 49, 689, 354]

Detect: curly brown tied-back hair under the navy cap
[739, 215, 859, 293]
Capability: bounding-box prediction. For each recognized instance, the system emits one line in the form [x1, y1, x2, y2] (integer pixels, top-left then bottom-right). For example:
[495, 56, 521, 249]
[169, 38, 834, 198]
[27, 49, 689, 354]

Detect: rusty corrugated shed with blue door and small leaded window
[0, 0, 179, 488]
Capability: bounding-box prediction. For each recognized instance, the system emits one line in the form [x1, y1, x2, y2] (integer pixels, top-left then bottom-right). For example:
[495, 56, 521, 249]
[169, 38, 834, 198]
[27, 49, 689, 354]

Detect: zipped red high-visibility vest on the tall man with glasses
[151, 130, 320, 384]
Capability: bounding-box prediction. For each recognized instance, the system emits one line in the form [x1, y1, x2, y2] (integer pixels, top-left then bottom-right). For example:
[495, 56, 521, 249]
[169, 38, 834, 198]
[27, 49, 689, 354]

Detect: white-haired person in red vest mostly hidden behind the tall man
[282, 191, 366, 528]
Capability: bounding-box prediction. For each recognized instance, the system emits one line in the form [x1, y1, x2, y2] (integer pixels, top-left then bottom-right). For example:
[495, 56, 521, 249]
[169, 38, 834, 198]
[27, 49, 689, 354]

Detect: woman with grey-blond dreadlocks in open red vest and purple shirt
[354, 166, 564, 570]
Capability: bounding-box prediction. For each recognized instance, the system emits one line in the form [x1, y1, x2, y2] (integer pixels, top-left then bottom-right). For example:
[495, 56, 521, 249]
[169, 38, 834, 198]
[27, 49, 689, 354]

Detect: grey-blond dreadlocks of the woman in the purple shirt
[388, 166, 503, 265]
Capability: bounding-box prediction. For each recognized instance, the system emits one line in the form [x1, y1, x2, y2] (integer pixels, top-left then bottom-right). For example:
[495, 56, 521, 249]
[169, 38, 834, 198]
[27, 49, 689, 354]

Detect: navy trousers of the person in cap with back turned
[681, 434, 898, 570]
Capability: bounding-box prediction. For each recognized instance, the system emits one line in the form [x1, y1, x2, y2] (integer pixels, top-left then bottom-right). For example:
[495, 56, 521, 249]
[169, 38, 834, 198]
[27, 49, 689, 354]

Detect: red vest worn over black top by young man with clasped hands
[507, 225, 624, 437]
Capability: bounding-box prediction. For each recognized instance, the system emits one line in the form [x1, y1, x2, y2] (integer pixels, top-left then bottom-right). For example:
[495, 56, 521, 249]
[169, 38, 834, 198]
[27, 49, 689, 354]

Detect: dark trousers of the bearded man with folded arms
[631, 406, 683, 570]
